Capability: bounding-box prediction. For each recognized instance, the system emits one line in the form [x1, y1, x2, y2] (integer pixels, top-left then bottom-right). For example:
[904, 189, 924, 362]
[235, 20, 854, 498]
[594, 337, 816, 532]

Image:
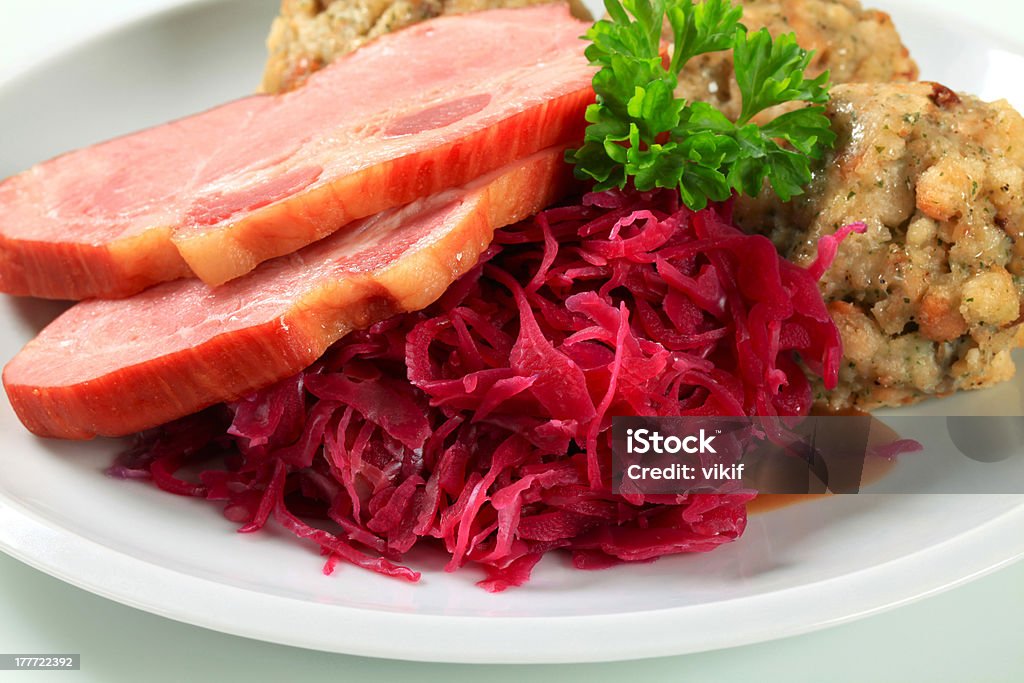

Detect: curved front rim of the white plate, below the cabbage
[0, 495, 1024, 664]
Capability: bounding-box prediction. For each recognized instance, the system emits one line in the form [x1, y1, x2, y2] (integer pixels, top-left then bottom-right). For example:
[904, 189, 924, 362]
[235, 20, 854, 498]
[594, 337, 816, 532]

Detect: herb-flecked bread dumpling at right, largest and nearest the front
[736, 83, 1024, 409]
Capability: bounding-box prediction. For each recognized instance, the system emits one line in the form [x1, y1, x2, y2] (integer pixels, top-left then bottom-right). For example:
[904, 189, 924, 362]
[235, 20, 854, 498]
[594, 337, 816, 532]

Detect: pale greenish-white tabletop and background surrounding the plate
[0, 0, 1024, 683]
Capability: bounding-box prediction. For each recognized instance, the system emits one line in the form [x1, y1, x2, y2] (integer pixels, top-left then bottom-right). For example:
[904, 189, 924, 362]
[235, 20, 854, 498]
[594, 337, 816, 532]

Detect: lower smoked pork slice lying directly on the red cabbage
[3, 147, 571, 438]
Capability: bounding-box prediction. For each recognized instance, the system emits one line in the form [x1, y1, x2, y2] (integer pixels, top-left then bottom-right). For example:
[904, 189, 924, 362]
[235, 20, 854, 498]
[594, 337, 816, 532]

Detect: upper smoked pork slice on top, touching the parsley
[0, 6, 593, 299]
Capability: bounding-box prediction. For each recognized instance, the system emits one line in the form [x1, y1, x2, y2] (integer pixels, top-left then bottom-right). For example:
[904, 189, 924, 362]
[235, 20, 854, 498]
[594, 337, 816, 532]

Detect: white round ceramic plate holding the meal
[0, 0, 1024, 663]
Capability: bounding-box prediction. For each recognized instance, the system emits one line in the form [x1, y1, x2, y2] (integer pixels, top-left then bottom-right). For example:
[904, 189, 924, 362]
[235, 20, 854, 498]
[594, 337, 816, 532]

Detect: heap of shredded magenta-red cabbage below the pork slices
[112, 190, 841, 591]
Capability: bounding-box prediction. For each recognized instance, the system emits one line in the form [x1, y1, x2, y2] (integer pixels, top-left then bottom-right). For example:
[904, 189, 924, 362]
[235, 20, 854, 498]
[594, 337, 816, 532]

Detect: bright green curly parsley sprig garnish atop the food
[566, 0, 836, 210]
